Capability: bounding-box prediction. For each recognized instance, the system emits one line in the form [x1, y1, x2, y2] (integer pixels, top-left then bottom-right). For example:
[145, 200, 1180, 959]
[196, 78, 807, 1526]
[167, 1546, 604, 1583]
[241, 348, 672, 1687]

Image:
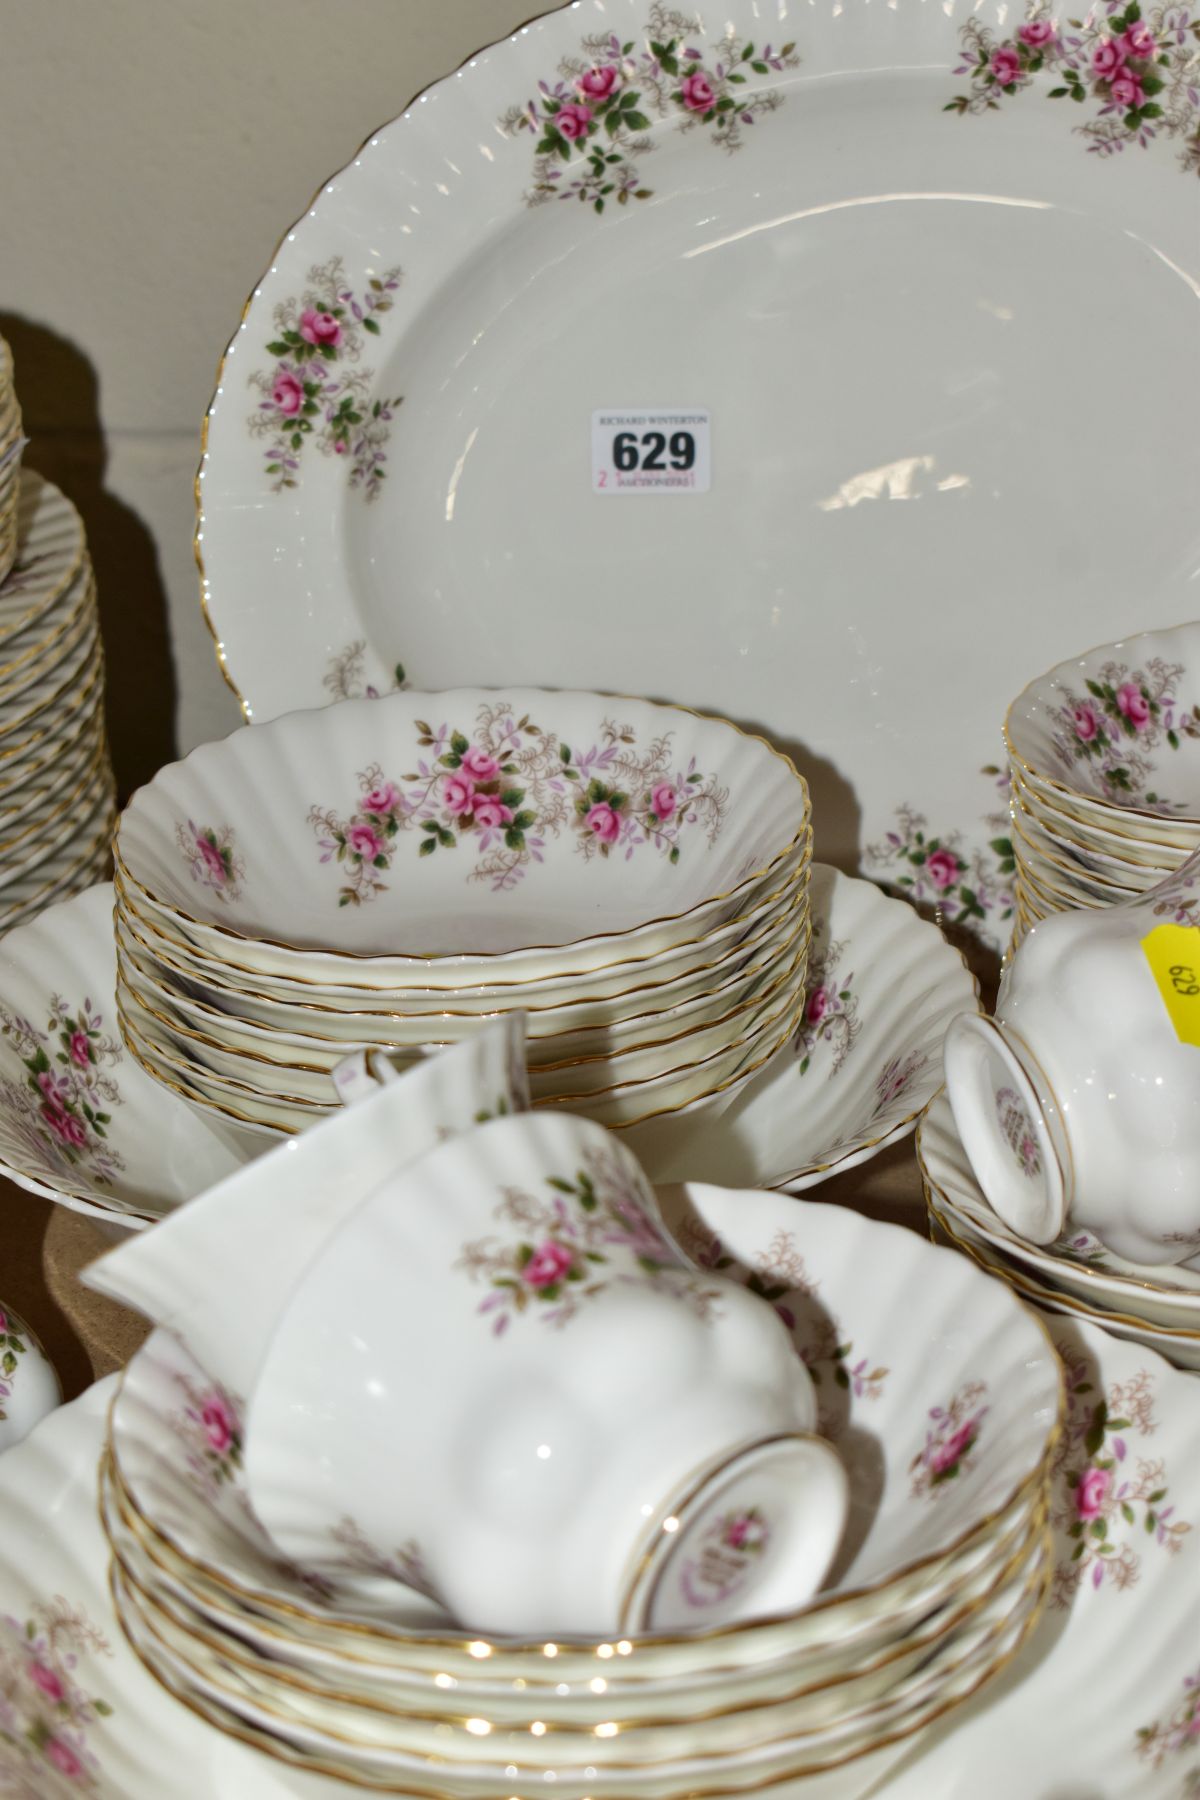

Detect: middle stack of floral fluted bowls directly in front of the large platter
[117, 689, 811, 1132]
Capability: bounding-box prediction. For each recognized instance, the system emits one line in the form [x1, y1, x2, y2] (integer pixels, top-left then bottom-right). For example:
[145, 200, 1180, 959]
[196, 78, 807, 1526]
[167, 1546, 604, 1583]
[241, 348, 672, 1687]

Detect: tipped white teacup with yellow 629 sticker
[945, 853, 1200, 1264]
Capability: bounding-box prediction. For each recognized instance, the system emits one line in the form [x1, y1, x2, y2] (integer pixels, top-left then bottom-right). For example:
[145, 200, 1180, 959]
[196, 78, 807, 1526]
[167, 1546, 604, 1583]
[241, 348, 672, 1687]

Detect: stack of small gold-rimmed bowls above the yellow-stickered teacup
[1004, 625, 1200, 941]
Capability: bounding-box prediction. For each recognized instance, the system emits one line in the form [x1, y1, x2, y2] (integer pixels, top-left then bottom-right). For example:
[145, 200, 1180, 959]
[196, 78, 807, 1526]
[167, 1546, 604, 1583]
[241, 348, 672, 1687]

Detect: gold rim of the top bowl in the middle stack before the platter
[117, 698, 813, 974]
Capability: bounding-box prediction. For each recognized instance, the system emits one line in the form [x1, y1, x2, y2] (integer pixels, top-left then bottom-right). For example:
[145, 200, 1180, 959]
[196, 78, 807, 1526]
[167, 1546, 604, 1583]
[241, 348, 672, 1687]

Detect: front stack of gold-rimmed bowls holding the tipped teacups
[103, 1188, 1060, 1800]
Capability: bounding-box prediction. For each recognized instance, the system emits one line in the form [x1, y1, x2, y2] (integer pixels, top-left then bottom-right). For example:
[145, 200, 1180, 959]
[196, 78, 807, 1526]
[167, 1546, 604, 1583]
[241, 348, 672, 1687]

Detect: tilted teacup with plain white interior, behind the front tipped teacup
[81, 1013, 529, 1395]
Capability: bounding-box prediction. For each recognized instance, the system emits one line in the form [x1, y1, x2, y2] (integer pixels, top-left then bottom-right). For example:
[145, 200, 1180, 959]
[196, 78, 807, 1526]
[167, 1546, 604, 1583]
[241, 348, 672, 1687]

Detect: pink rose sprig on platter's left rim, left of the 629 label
[248, 256, 401, 500]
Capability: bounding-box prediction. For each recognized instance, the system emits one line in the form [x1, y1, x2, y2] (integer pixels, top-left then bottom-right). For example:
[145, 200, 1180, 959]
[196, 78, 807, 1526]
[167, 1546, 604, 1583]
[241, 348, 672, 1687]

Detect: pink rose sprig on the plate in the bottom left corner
[0, 1595, 113, 1800]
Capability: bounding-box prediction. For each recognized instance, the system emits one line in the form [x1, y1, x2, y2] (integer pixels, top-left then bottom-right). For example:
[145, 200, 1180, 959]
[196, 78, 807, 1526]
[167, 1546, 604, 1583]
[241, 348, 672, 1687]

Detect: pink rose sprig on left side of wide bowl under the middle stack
[0, 994, 124, 1186]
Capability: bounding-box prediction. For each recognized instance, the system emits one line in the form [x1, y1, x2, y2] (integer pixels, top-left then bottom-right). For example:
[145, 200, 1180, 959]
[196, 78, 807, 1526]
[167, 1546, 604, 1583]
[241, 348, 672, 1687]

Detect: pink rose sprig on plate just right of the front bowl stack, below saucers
[1052, 1359, 1191, 1609]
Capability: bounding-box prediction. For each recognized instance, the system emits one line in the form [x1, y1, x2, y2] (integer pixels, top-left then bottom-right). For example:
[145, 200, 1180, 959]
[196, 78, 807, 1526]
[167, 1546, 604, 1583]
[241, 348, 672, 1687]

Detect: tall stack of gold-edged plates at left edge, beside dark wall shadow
[0, 470, 115, 931]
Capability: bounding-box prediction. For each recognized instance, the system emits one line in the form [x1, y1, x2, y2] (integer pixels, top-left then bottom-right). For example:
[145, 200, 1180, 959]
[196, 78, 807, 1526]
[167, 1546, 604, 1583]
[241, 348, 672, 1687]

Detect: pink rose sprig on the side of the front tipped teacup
[455, 1148, 718, 1337]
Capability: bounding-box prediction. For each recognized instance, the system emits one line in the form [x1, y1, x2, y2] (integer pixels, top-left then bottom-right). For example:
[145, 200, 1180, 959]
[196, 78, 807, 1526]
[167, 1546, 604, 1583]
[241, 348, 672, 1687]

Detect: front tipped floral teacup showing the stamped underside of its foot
[245, 1112, 847, 1636]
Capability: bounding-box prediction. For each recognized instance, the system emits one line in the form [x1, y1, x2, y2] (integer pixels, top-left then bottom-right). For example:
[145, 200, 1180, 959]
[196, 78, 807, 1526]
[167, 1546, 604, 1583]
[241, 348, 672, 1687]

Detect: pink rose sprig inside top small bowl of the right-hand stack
[1054, 657, 1200, 812]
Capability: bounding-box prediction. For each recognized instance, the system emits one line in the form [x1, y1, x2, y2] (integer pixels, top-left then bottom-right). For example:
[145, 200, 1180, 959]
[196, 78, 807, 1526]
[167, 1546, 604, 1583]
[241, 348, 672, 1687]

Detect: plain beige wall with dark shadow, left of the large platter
[0, 0, 538, 792]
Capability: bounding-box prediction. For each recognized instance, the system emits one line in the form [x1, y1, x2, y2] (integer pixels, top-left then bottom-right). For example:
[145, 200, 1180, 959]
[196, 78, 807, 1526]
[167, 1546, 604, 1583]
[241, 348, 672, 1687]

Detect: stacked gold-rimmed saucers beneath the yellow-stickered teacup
[918, 1091, 1200, 1368]
